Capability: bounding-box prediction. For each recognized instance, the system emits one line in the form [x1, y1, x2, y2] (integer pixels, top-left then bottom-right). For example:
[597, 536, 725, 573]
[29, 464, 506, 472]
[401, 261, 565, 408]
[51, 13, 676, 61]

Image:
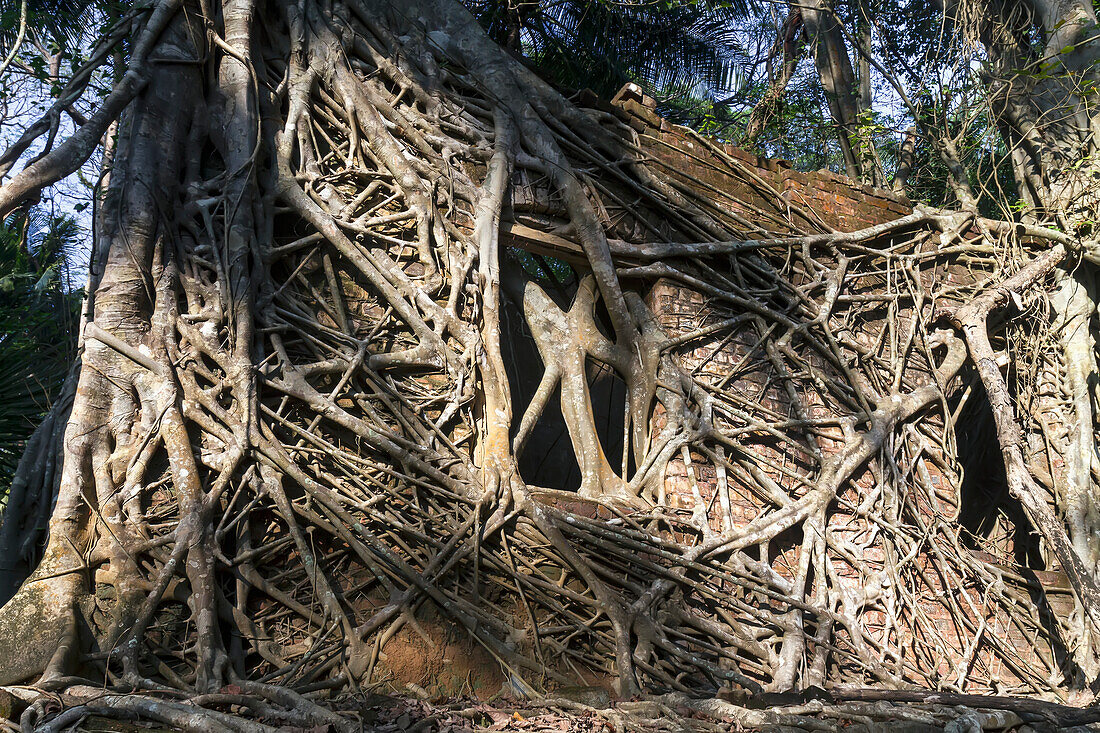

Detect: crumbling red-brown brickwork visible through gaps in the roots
[614, 86, 1074, 686]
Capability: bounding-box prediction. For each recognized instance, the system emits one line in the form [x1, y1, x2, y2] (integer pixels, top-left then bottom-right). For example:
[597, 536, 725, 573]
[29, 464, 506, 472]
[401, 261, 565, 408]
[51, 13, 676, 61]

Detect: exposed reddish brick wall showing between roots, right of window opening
[613, 87, 1074, 689]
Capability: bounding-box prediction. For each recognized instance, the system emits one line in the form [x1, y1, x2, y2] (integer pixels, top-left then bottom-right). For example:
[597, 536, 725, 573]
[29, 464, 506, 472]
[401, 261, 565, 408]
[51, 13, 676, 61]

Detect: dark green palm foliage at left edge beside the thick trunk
[0, 211, 81, 493]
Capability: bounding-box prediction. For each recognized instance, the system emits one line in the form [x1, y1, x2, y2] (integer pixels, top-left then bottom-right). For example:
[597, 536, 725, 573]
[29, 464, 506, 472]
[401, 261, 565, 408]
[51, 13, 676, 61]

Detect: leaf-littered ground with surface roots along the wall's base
[0, 686, 1100, 733]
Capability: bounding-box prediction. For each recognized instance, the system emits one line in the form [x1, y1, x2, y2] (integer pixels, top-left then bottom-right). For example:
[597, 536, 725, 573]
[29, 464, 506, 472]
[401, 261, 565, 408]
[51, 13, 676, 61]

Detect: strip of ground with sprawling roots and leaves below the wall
[0, 686, 1100, 733]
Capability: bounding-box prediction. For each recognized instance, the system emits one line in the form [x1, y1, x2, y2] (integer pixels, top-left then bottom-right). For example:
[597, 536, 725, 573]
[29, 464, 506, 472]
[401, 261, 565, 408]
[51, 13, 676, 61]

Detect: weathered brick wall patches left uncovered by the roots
[613, 86, 1075, 687]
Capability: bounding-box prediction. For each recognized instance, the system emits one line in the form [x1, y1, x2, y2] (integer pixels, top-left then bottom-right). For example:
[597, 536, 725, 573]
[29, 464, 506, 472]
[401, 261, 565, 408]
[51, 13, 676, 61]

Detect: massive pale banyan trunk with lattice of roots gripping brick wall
[0, 0, 1096, 722]
